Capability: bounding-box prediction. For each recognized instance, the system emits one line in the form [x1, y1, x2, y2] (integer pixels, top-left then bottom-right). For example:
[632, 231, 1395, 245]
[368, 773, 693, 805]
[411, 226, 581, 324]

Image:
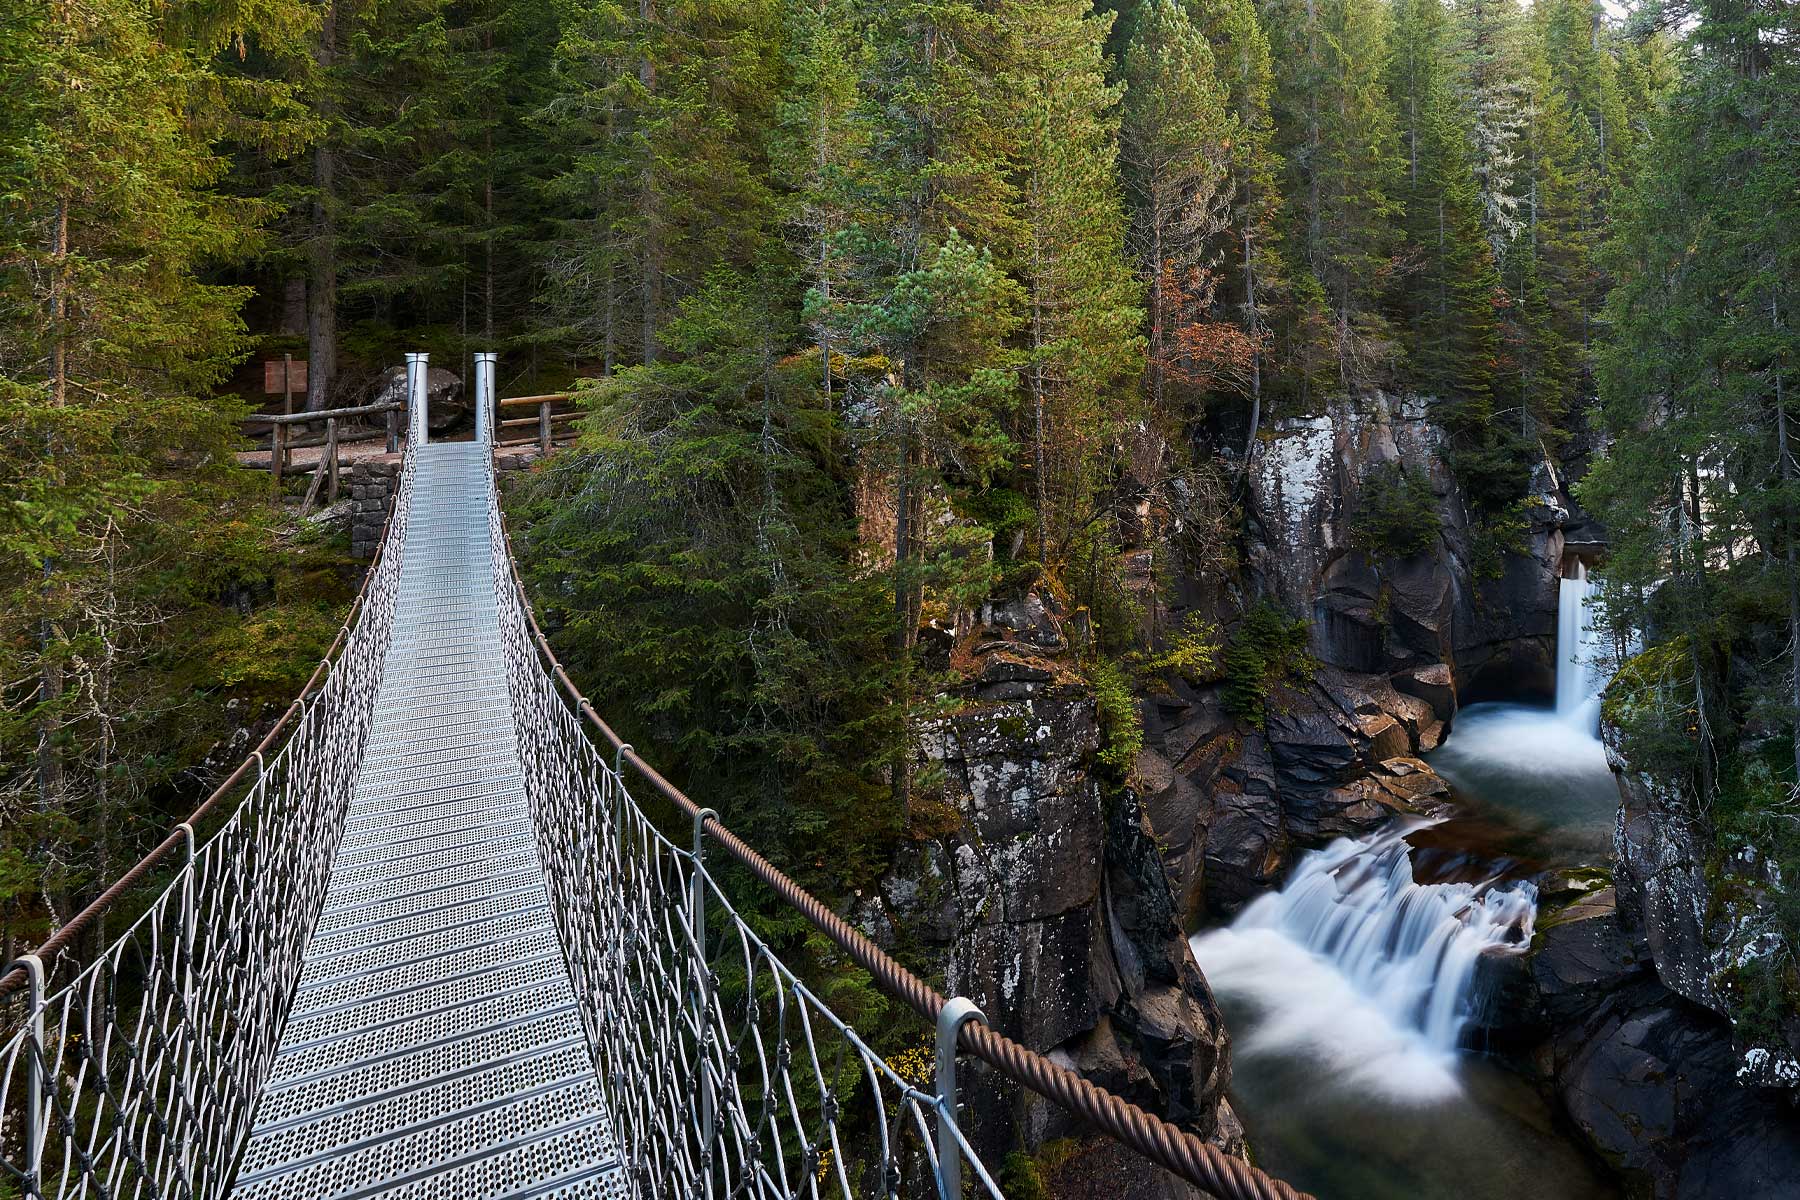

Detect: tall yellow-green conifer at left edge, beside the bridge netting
[0, 0, 306, 941]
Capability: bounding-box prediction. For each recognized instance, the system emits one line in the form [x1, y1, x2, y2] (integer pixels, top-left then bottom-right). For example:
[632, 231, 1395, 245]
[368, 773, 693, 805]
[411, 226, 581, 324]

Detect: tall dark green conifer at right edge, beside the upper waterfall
[1580, 2, 1800, 798]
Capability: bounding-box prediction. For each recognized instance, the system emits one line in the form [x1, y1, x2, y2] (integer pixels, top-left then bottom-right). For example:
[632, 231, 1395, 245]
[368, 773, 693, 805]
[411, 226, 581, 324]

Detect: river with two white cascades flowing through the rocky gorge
[1192, 572, 1618, 1200]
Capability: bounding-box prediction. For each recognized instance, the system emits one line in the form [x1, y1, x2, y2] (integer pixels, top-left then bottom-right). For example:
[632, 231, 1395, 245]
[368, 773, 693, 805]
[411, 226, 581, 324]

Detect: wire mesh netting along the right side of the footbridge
[490, 464, 1001, 1200]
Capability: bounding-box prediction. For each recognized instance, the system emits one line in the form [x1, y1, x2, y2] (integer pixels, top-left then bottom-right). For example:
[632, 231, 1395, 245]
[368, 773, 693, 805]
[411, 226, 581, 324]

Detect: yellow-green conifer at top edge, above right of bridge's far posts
[538, 0, 781, 365]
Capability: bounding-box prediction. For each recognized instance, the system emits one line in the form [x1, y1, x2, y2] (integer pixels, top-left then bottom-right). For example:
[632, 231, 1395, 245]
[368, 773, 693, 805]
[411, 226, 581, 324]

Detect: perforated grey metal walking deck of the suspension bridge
[232, 443, 625, 1200]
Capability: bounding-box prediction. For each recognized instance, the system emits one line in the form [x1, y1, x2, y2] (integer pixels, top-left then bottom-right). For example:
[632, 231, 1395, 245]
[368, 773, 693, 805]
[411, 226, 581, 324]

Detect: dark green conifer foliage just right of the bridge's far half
[513, 272, 900, 894]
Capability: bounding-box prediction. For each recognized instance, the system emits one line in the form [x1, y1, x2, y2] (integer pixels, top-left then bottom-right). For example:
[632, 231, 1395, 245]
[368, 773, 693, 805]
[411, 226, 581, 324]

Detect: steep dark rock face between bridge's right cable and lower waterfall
[855, 683, 1235, 1162]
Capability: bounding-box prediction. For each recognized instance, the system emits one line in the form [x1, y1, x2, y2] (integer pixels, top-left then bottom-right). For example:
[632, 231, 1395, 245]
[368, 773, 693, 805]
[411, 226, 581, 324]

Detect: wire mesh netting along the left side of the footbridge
[0, 453, 414, 1200]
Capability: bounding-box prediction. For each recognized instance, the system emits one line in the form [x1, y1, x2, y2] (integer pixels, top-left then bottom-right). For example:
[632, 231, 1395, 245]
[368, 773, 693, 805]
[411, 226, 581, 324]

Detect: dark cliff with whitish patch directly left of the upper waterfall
[1139, 392, 1580, 923]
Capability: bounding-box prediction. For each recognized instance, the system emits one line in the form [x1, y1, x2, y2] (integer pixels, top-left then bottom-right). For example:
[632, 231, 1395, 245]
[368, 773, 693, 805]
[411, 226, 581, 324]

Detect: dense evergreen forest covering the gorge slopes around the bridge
[0, 0, 1800, 1196]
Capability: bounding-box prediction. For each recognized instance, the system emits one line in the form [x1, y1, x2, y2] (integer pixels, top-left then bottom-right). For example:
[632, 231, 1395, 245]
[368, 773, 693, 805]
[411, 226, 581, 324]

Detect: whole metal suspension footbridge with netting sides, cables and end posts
[0, 354, 1303, 1200]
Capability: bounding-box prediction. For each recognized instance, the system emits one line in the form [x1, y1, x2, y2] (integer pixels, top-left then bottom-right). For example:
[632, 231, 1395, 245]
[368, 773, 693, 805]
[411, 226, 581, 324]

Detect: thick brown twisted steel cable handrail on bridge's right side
[495, 509, 1312, 1200]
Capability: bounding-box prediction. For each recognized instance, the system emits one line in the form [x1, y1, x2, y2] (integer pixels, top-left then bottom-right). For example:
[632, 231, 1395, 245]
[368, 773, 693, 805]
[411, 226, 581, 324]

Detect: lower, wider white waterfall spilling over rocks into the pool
[1193, 822, 1537, 1096]
